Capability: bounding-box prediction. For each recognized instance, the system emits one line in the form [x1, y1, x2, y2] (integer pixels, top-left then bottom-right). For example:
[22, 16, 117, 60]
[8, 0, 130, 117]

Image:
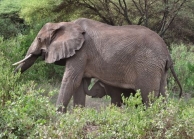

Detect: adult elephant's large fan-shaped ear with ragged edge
[45, 22, 84, 63]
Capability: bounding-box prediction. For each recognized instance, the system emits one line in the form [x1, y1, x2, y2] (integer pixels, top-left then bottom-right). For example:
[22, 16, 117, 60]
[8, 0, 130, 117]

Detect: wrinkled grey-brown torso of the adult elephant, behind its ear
[81, 18, 169, 88]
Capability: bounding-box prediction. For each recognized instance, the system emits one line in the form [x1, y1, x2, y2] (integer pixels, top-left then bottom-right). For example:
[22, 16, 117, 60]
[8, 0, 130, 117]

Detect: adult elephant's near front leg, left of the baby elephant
[56, 66, 84, 112]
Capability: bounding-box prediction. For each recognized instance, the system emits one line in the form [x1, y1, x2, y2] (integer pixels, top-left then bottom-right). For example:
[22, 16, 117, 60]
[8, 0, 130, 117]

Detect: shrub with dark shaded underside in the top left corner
[0, 0, 28, 39]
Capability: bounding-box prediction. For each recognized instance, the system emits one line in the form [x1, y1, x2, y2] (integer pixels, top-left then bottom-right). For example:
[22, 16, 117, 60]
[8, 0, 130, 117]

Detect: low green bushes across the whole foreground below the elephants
[0, 83, 194, 139]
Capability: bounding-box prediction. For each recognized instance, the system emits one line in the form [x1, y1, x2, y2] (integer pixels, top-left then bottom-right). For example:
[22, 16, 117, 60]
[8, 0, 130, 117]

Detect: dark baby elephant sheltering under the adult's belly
[84, 80, 136, 107]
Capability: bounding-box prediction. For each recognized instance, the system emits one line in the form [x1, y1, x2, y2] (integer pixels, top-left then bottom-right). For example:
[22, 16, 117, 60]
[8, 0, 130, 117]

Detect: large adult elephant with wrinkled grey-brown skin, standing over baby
[15, 18, 182, 112]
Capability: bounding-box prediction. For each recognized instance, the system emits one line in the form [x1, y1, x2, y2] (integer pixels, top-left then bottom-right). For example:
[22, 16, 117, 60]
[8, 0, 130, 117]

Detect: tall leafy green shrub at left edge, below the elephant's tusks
[0, 52, 55, 138]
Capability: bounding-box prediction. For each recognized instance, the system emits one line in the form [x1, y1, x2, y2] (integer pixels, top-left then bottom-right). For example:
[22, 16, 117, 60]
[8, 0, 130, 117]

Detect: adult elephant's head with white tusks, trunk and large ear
[13, 22, 84, 72]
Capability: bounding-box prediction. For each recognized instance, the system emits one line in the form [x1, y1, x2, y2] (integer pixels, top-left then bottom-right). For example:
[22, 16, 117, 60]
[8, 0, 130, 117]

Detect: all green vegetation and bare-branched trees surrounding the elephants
[0, 0, 194, 139]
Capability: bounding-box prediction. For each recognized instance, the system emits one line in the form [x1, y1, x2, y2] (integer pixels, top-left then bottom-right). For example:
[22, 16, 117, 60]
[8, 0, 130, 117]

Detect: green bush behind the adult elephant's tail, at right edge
[169, 44, 194, 96]
